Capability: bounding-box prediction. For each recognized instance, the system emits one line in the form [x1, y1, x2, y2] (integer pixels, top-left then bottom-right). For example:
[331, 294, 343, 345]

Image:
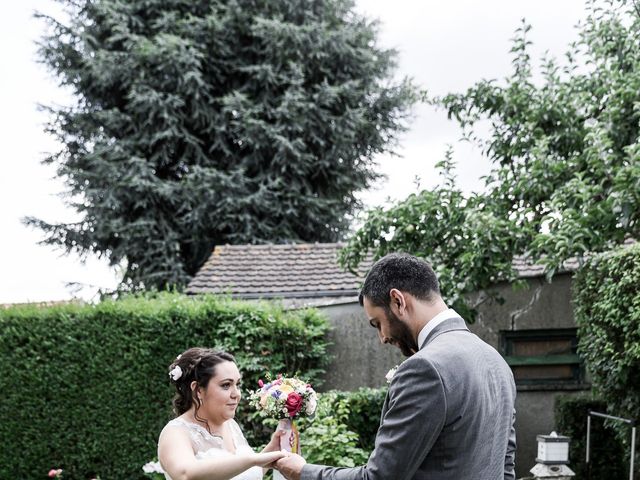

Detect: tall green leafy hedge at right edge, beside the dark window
[573, 244, 640, 436]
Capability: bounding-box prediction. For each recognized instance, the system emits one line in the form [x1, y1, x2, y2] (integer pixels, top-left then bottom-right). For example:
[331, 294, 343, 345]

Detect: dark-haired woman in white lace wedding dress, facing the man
[158, 348, 285, 480]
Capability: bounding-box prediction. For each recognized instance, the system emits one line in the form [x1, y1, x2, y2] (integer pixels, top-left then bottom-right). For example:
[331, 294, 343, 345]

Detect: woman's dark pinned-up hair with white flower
[169, 347, 236, 424]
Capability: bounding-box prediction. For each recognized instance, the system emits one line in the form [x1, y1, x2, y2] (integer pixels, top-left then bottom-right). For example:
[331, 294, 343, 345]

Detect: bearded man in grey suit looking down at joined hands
[276, 254, 516, 480]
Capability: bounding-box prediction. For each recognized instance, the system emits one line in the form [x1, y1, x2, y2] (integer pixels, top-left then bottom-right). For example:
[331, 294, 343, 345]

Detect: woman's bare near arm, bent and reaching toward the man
[158, 428, 284, 480]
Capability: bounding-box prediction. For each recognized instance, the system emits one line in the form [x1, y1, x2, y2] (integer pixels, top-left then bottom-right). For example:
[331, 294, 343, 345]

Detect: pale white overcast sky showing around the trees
[0, 0, 584, 304]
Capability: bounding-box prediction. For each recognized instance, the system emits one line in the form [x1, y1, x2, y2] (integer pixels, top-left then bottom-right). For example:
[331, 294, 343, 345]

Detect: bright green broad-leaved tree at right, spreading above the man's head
[342, 0, 640, 312]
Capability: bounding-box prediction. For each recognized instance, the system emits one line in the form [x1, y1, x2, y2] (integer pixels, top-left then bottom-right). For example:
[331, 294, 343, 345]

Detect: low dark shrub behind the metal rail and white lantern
[555, 396, 628, 480]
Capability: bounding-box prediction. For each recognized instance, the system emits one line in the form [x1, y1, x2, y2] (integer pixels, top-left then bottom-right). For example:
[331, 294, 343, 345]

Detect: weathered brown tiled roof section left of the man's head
[187, 243, 370, 298]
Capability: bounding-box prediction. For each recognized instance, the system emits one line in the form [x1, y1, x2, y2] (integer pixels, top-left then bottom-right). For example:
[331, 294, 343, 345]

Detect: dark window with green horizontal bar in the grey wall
[501, 328, 584, 389]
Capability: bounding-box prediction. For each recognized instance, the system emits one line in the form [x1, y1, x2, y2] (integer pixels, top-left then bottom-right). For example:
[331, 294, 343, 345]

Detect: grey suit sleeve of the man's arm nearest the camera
[300, 356, 446, 480]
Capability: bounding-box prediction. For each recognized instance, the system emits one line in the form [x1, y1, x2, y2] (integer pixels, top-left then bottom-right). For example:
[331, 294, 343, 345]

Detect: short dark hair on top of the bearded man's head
[359, 253, 440, 309]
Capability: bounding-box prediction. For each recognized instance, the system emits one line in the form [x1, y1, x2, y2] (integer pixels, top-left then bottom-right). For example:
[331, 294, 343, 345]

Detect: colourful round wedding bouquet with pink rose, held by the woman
[250, 375, 318, 468]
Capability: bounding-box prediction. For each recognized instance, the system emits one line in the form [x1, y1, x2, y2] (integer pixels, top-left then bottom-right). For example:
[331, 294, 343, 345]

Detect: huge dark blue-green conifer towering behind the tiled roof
[31, 0, 414, 288]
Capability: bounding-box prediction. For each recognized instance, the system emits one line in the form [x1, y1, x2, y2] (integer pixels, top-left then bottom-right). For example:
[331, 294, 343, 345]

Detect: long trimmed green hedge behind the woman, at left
[0, 294, 329, 480]
